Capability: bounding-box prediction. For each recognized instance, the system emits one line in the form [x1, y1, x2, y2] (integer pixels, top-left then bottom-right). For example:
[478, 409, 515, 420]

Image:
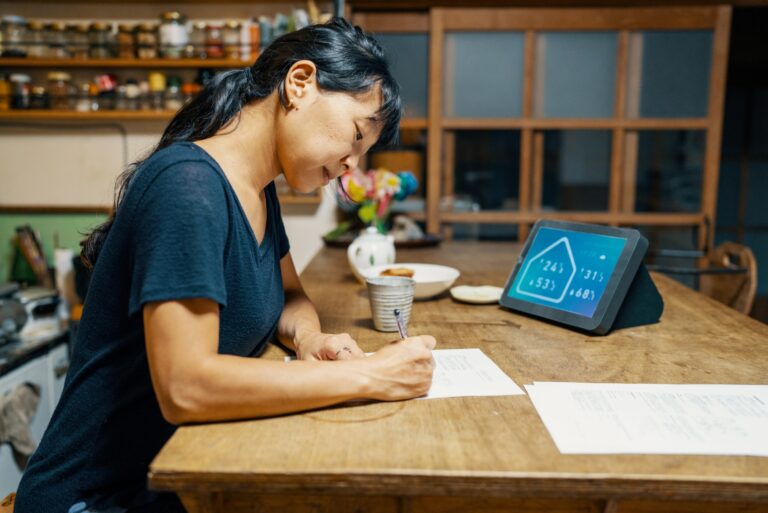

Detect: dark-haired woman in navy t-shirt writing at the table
[16, 19, 435, 513]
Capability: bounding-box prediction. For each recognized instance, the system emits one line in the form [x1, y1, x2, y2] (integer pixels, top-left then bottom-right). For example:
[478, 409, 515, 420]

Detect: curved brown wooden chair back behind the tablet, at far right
[699, 242, 757, 315]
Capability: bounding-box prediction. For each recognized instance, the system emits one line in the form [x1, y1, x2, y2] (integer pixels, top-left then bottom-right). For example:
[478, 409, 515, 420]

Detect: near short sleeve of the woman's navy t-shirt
[128, 161, 229, 315]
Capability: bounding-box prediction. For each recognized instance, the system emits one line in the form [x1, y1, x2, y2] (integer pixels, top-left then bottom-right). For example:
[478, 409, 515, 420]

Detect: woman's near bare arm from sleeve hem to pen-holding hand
[143, 299, 435, 424]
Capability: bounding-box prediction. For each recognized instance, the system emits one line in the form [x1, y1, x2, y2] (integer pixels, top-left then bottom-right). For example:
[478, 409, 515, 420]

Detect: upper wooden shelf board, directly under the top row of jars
[0, 57, 252, 69]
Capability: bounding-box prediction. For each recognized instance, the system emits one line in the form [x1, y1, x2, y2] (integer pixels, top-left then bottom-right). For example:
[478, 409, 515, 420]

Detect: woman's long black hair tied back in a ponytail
[80, 18, 402, 268]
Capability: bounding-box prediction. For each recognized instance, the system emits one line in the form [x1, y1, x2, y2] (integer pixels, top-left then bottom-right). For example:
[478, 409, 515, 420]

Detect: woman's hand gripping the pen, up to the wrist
[361, 335, 435, 401]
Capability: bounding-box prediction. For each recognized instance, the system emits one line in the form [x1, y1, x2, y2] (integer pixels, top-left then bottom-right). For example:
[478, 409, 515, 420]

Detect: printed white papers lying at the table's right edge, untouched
[525, 382, 768, 456]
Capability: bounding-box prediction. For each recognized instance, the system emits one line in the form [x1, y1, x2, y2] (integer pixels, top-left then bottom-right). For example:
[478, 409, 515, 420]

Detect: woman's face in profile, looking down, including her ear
[277, 61, 381, 192]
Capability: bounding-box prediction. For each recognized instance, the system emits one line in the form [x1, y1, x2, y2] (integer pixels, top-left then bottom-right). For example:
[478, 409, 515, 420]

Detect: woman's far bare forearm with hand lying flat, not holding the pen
[277, 253, 365, 360]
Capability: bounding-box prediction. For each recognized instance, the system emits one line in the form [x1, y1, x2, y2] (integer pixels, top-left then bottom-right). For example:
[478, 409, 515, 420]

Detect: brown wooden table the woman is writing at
[150, 243, 768, 513]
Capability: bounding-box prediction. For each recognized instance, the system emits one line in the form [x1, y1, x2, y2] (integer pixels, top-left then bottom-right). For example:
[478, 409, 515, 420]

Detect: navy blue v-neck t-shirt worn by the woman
[15, 143, 288, 513]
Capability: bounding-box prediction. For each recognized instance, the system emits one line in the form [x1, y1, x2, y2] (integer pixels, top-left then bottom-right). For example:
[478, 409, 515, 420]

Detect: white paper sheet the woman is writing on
[285, 349, 525, 399]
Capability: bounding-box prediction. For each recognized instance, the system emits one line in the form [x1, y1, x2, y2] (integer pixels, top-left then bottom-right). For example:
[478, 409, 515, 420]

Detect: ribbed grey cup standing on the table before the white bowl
[365, 276, 416, 331]
